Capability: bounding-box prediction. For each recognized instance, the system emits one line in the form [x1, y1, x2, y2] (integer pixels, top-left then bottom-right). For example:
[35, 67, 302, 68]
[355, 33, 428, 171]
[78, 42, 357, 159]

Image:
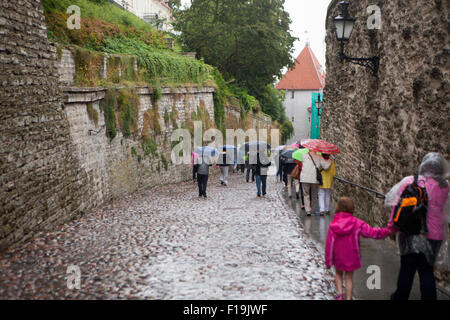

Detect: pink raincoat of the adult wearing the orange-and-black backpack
[388, 176, 449, 240]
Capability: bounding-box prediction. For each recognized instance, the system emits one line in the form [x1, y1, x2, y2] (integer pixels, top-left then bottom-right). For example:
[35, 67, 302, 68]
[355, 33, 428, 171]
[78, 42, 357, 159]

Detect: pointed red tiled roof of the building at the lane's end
[276, 45, 325, 90]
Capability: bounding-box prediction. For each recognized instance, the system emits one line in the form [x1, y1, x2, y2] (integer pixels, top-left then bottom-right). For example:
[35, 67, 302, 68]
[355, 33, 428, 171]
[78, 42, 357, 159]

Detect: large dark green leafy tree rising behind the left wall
[174, 0, 296, 127]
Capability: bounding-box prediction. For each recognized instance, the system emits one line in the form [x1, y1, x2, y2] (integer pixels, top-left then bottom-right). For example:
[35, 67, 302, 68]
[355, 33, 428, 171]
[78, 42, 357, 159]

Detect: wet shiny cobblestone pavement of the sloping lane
[0, 174, 334, 300]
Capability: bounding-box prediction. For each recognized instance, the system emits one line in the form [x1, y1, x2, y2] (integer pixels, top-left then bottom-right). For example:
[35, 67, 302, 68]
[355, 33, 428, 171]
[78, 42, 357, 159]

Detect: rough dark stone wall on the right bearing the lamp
[321, 0, 450, 225]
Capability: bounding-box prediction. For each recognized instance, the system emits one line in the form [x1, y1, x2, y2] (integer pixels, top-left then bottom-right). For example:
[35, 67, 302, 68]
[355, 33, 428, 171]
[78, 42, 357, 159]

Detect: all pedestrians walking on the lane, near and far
[192, 149, 450, 300]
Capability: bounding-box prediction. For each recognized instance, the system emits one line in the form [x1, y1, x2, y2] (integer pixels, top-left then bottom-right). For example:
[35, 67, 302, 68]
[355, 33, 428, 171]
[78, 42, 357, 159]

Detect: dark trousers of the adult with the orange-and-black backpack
[391, 253, 437, 300]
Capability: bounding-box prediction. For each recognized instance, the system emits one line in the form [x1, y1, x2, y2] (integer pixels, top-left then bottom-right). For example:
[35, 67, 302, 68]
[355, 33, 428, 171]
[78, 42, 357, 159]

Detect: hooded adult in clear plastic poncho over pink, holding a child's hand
[385, 152, 449, 300]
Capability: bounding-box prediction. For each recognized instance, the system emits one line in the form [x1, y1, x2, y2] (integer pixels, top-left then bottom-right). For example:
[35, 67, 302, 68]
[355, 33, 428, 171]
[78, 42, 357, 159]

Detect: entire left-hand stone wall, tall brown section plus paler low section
[0, 0, 276, 250]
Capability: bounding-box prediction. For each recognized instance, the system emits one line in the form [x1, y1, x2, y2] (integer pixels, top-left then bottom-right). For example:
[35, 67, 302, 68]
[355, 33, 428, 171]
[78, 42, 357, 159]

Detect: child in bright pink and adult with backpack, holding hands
[325, 153, 450, 300]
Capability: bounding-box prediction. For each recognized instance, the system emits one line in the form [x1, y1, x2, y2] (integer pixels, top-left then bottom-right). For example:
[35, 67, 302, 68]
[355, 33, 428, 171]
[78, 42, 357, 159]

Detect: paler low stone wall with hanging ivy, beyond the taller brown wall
[64, 87, 214, 207]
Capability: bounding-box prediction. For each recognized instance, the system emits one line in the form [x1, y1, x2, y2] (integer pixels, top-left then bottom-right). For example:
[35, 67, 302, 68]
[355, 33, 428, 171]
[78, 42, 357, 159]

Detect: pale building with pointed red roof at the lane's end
[276, 44, 325, 143]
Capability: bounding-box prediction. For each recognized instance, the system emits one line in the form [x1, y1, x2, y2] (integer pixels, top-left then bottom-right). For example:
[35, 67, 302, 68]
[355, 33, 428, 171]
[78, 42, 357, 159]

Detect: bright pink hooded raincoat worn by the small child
[325, 212, 390, 271]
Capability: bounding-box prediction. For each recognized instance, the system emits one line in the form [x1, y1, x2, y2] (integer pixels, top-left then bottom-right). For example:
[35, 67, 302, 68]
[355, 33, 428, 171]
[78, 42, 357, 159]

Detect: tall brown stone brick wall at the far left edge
[0, 0, 87, 249]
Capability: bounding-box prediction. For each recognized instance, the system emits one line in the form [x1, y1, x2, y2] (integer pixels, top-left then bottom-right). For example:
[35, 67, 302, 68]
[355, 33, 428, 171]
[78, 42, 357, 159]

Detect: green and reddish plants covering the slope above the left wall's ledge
[43, 0, 210, 85]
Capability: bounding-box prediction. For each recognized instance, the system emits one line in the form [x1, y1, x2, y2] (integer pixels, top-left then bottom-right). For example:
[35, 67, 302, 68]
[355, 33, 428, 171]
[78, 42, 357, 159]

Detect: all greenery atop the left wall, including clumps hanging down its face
[42, 0, 283, 139]
